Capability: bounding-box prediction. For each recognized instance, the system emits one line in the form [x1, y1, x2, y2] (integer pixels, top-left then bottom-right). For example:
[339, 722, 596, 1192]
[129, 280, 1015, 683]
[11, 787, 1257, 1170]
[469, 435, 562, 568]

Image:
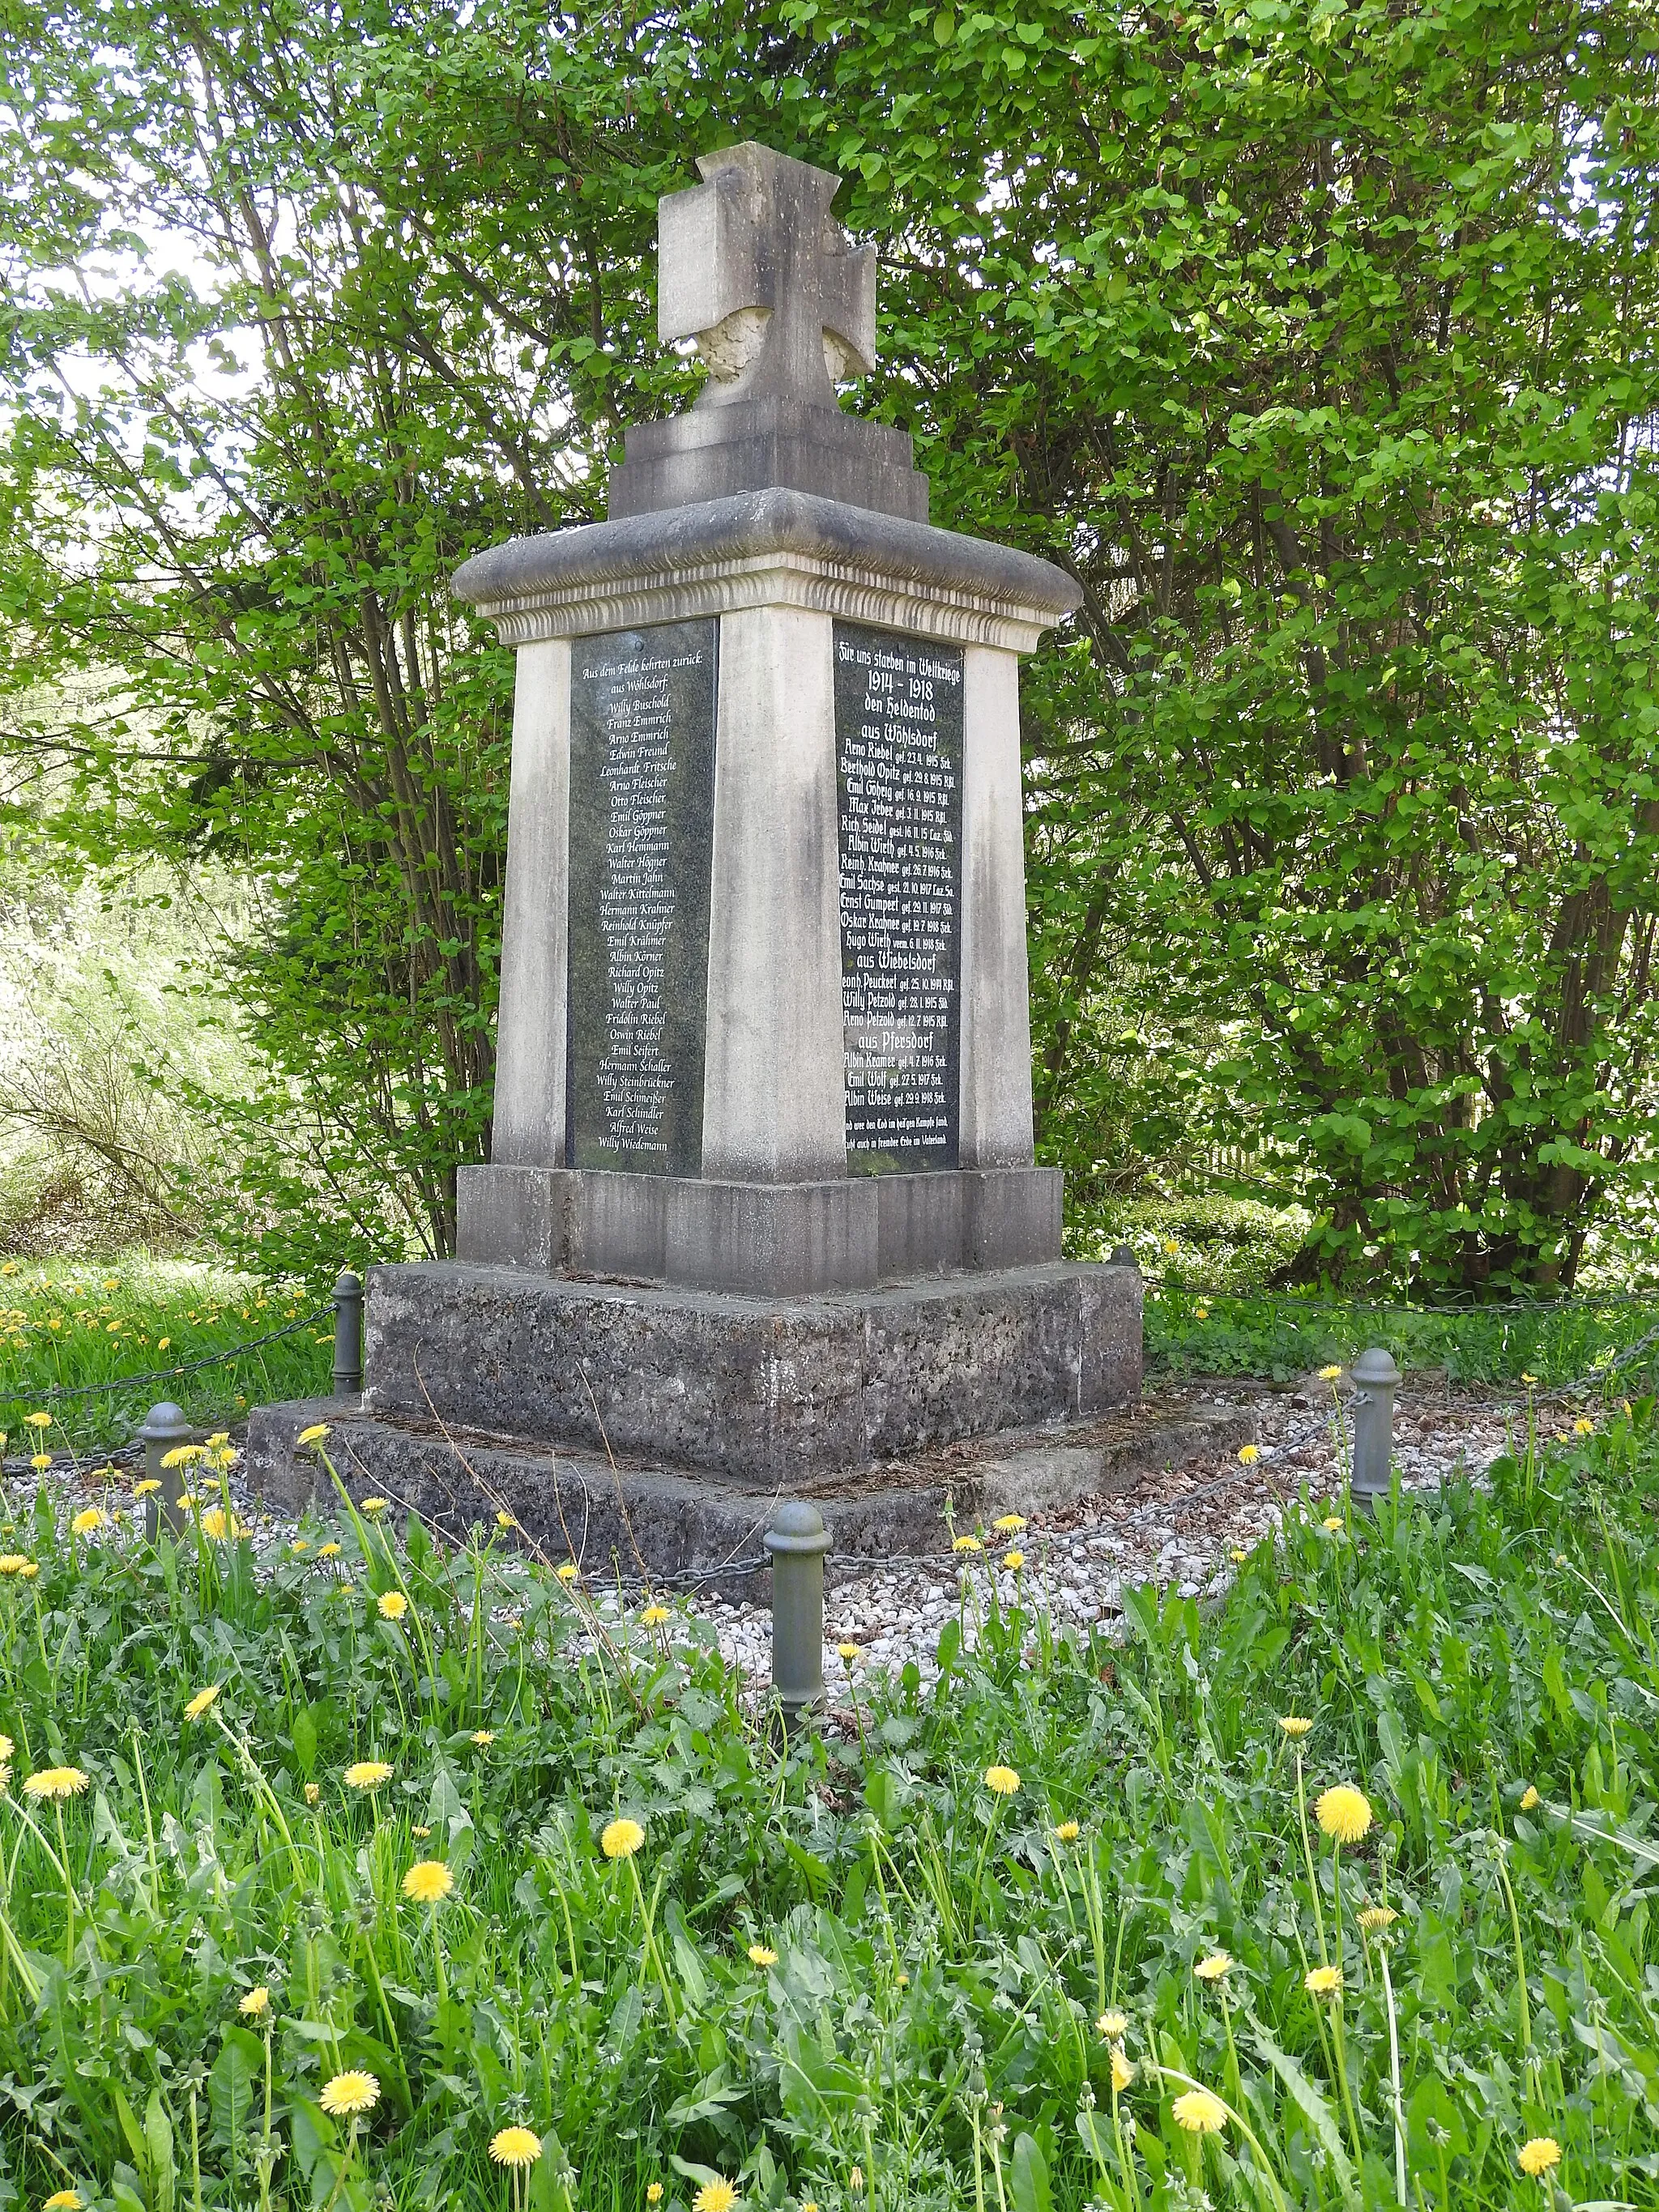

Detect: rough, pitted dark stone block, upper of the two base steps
[367, 1263, 1141, 1482]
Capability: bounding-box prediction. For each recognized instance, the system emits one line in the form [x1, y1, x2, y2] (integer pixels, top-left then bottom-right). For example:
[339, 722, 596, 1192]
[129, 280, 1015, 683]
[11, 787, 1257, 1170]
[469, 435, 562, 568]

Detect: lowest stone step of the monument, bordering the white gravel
[248, 1398, 1256, 1601]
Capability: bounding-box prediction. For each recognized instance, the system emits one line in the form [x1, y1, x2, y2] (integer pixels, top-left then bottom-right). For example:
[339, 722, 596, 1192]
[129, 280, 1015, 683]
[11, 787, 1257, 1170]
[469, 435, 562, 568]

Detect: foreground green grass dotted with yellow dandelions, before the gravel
[0, 1400, 1659, 2212]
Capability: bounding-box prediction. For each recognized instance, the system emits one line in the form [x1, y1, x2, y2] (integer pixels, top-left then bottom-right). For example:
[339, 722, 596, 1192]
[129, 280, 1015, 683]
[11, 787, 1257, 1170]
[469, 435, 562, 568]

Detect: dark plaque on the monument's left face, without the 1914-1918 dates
[566, 621, 719, 1174]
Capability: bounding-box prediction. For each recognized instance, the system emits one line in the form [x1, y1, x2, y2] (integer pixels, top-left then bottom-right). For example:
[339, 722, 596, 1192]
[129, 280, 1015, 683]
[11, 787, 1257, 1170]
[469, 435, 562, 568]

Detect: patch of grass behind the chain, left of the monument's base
[0, 1254, 332, 1455]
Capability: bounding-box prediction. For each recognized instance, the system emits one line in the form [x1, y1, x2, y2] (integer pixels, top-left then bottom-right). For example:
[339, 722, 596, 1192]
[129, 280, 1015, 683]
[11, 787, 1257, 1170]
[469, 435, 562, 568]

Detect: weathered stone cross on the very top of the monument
[657, 142, 876, 407]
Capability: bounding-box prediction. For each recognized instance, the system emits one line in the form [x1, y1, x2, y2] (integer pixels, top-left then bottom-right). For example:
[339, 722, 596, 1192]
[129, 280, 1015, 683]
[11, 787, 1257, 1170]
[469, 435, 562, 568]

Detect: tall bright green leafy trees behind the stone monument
[0, 0, 1659, 1289]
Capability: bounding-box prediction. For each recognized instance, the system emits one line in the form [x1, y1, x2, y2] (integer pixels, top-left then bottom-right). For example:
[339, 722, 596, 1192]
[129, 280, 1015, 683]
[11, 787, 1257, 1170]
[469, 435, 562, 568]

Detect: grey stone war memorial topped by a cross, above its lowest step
[253, 144, 1141, 1566]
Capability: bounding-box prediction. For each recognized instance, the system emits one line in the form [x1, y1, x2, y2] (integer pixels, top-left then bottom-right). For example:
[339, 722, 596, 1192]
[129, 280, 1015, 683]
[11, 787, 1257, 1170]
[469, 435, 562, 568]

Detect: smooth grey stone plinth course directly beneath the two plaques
[458, 1164, 1062, 1298]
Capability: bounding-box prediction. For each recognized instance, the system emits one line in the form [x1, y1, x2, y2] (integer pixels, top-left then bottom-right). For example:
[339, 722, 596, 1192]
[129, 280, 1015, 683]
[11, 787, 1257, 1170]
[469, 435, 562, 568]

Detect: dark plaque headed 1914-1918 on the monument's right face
[836, 621, 962, 1174]
